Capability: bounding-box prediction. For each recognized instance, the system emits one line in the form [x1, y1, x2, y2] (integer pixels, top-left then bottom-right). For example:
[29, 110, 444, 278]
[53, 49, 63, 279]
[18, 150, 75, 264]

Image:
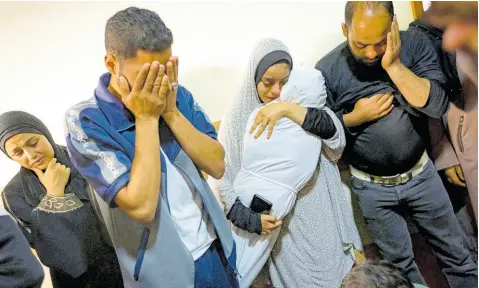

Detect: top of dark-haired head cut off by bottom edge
[341, 261, 414, 288]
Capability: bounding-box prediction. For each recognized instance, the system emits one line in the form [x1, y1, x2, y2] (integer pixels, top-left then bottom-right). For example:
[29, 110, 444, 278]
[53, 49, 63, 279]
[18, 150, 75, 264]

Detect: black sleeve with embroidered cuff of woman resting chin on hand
[3, 185, 99, 278]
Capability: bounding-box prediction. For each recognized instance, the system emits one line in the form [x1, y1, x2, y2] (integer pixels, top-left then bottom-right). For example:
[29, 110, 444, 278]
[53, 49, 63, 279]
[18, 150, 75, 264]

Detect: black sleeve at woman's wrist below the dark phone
[226, 198, 262, 235]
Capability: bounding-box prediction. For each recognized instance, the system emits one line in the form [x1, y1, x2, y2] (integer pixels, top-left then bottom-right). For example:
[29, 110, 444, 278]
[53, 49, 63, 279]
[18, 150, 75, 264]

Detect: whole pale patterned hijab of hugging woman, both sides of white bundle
[208, 39, 362, 266]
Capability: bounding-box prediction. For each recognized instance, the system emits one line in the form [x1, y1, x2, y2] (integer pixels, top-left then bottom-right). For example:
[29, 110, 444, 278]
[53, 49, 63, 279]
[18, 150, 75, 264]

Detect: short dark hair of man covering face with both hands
[105, 7, 173, 59]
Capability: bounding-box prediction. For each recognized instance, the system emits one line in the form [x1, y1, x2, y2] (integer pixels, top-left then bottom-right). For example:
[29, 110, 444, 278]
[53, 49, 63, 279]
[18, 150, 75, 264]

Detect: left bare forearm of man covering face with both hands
[116, 119, 161, 222]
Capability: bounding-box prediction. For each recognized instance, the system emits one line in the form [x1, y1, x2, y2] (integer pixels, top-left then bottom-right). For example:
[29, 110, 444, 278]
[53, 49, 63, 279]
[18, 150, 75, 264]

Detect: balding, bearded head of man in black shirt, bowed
[342, 1, 394, 67]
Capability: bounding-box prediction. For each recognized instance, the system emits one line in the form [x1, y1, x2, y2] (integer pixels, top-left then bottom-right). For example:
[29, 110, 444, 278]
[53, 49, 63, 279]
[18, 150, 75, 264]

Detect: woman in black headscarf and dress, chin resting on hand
[0, 111, 123, 288]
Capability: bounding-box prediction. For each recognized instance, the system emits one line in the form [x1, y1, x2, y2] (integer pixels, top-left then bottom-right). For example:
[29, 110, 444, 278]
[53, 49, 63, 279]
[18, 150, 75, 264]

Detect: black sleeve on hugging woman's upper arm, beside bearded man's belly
[301, 108, 336, 139]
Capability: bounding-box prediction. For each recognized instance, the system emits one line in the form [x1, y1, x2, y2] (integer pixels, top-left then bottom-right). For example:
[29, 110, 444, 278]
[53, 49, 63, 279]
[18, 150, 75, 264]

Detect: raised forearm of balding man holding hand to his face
[386, 63, 431, 108]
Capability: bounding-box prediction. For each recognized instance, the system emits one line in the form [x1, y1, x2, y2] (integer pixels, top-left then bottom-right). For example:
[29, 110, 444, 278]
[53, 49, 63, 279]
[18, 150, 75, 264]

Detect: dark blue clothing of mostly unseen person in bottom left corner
[0, 215, 44, 288]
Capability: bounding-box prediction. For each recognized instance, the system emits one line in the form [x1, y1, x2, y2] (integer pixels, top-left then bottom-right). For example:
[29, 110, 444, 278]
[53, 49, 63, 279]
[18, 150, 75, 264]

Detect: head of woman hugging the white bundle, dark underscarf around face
[254, 50, 293, 103]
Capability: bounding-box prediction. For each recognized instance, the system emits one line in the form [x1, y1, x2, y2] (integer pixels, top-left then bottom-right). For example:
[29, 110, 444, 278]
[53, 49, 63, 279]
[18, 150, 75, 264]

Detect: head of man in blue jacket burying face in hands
[104, 7, 176, 99]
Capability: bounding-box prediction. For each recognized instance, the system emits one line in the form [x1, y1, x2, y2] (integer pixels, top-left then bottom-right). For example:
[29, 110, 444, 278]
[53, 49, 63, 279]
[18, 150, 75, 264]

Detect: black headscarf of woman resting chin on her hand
[0, 111, 89, 206]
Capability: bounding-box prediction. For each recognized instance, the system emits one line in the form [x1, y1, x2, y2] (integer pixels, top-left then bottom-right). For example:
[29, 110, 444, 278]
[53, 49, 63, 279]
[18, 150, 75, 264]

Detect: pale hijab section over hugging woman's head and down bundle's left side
[208, 39, 289, 213]
